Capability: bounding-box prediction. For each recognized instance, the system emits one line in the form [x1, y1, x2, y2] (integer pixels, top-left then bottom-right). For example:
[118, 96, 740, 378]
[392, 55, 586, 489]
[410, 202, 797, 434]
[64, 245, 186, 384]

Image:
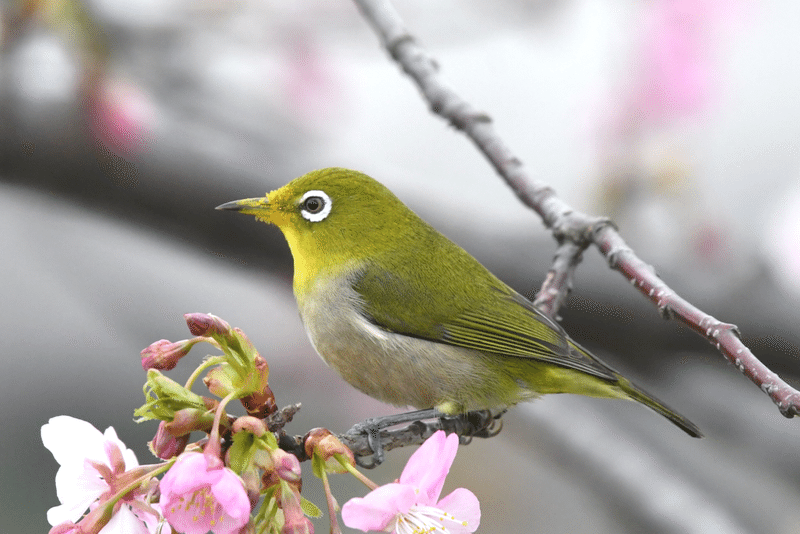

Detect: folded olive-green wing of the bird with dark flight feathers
[352, 257, 619, 382]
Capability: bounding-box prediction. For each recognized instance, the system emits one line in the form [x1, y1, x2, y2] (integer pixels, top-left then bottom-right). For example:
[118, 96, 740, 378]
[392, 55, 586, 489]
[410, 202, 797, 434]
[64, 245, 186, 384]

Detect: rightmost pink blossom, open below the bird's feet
[342, 430, 481, 534]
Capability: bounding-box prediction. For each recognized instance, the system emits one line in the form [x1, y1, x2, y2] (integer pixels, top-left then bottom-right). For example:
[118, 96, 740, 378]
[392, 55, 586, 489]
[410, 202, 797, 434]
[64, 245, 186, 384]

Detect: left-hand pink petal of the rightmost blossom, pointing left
[342, 483, 417, 532]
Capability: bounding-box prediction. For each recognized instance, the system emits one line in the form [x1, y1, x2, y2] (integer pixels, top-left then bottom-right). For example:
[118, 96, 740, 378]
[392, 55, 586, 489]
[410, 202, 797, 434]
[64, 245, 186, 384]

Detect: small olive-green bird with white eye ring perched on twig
[217, 168, 702, 437]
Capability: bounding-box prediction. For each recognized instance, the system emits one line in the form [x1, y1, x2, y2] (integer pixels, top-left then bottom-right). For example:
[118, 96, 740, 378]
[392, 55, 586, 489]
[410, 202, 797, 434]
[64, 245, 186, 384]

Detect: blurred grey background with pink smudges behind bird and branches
[0, 0, 800, 534]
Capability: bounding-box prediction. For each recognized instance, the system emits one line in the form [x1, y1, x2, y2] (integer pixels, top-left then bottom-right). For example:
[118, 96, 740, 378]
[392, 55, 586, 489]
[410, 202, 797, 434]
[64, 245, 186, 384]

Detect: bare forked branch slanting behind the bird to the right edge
[355, 0, 800, 417]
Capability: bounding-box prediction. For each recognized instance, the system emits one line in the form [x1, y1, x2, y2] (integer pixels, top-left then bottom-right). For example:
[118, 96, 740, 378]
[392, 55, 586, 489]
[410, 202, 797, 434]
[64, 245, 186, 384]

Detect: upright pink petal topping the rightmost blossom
[400, 430, 458, 505]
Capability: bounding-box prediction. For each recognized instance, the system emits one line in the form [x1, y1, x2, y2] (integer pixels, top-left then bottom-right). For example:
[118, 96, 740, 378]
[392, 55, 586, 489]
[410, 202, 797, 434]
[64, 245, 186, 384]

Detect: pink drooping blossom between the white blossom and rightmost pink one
[159, 452, 250, 534]
